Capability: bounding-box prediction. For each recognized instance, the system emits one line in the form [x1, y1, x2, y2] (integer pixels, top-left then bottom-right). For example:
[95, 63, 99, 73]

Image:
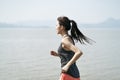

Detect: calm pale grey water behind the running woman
[0, 28, 120, 80]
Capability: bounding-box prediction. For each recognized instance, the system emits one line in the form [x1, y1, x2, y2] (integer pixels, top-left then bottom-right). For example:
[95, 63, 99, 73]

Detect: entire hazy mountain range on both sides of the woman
[0, 18, 120, 28]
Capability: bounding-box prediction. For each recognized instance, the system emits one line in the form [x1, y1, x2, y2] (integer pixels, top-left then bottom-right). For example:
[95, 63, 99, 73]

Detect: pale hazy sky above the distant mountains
[0, 0, 120, 23]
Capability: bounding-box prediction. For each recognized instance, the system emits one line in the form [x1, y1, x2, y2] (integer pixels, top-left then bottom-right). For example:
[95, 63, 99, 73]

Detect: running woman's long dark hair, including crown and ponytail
[57, 16, 93, 44]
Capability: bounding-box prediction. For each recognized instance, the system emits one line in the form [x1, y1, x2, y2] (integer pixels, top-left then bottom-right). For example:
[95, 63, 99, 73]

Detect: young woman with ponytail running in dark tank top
[50, 16, 90, 80]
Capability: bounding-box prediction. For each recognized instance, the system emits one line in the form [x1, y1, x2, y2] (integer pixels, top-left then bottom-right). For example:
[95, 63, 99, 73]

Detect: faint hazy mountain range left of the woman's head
[0, 20, 55, 28]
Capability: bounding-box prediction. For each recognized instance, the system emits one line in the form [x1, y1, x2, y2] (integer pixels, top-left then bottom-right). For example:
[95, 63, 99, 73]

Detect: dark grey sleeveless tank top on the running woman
[58, 43, 80, 78]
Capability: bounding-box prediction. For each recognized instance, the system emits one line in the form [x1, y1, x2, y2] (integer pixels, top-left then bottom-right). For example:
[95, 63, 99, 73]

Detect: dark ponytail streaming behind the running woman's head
[70, 20, 91, 44]
